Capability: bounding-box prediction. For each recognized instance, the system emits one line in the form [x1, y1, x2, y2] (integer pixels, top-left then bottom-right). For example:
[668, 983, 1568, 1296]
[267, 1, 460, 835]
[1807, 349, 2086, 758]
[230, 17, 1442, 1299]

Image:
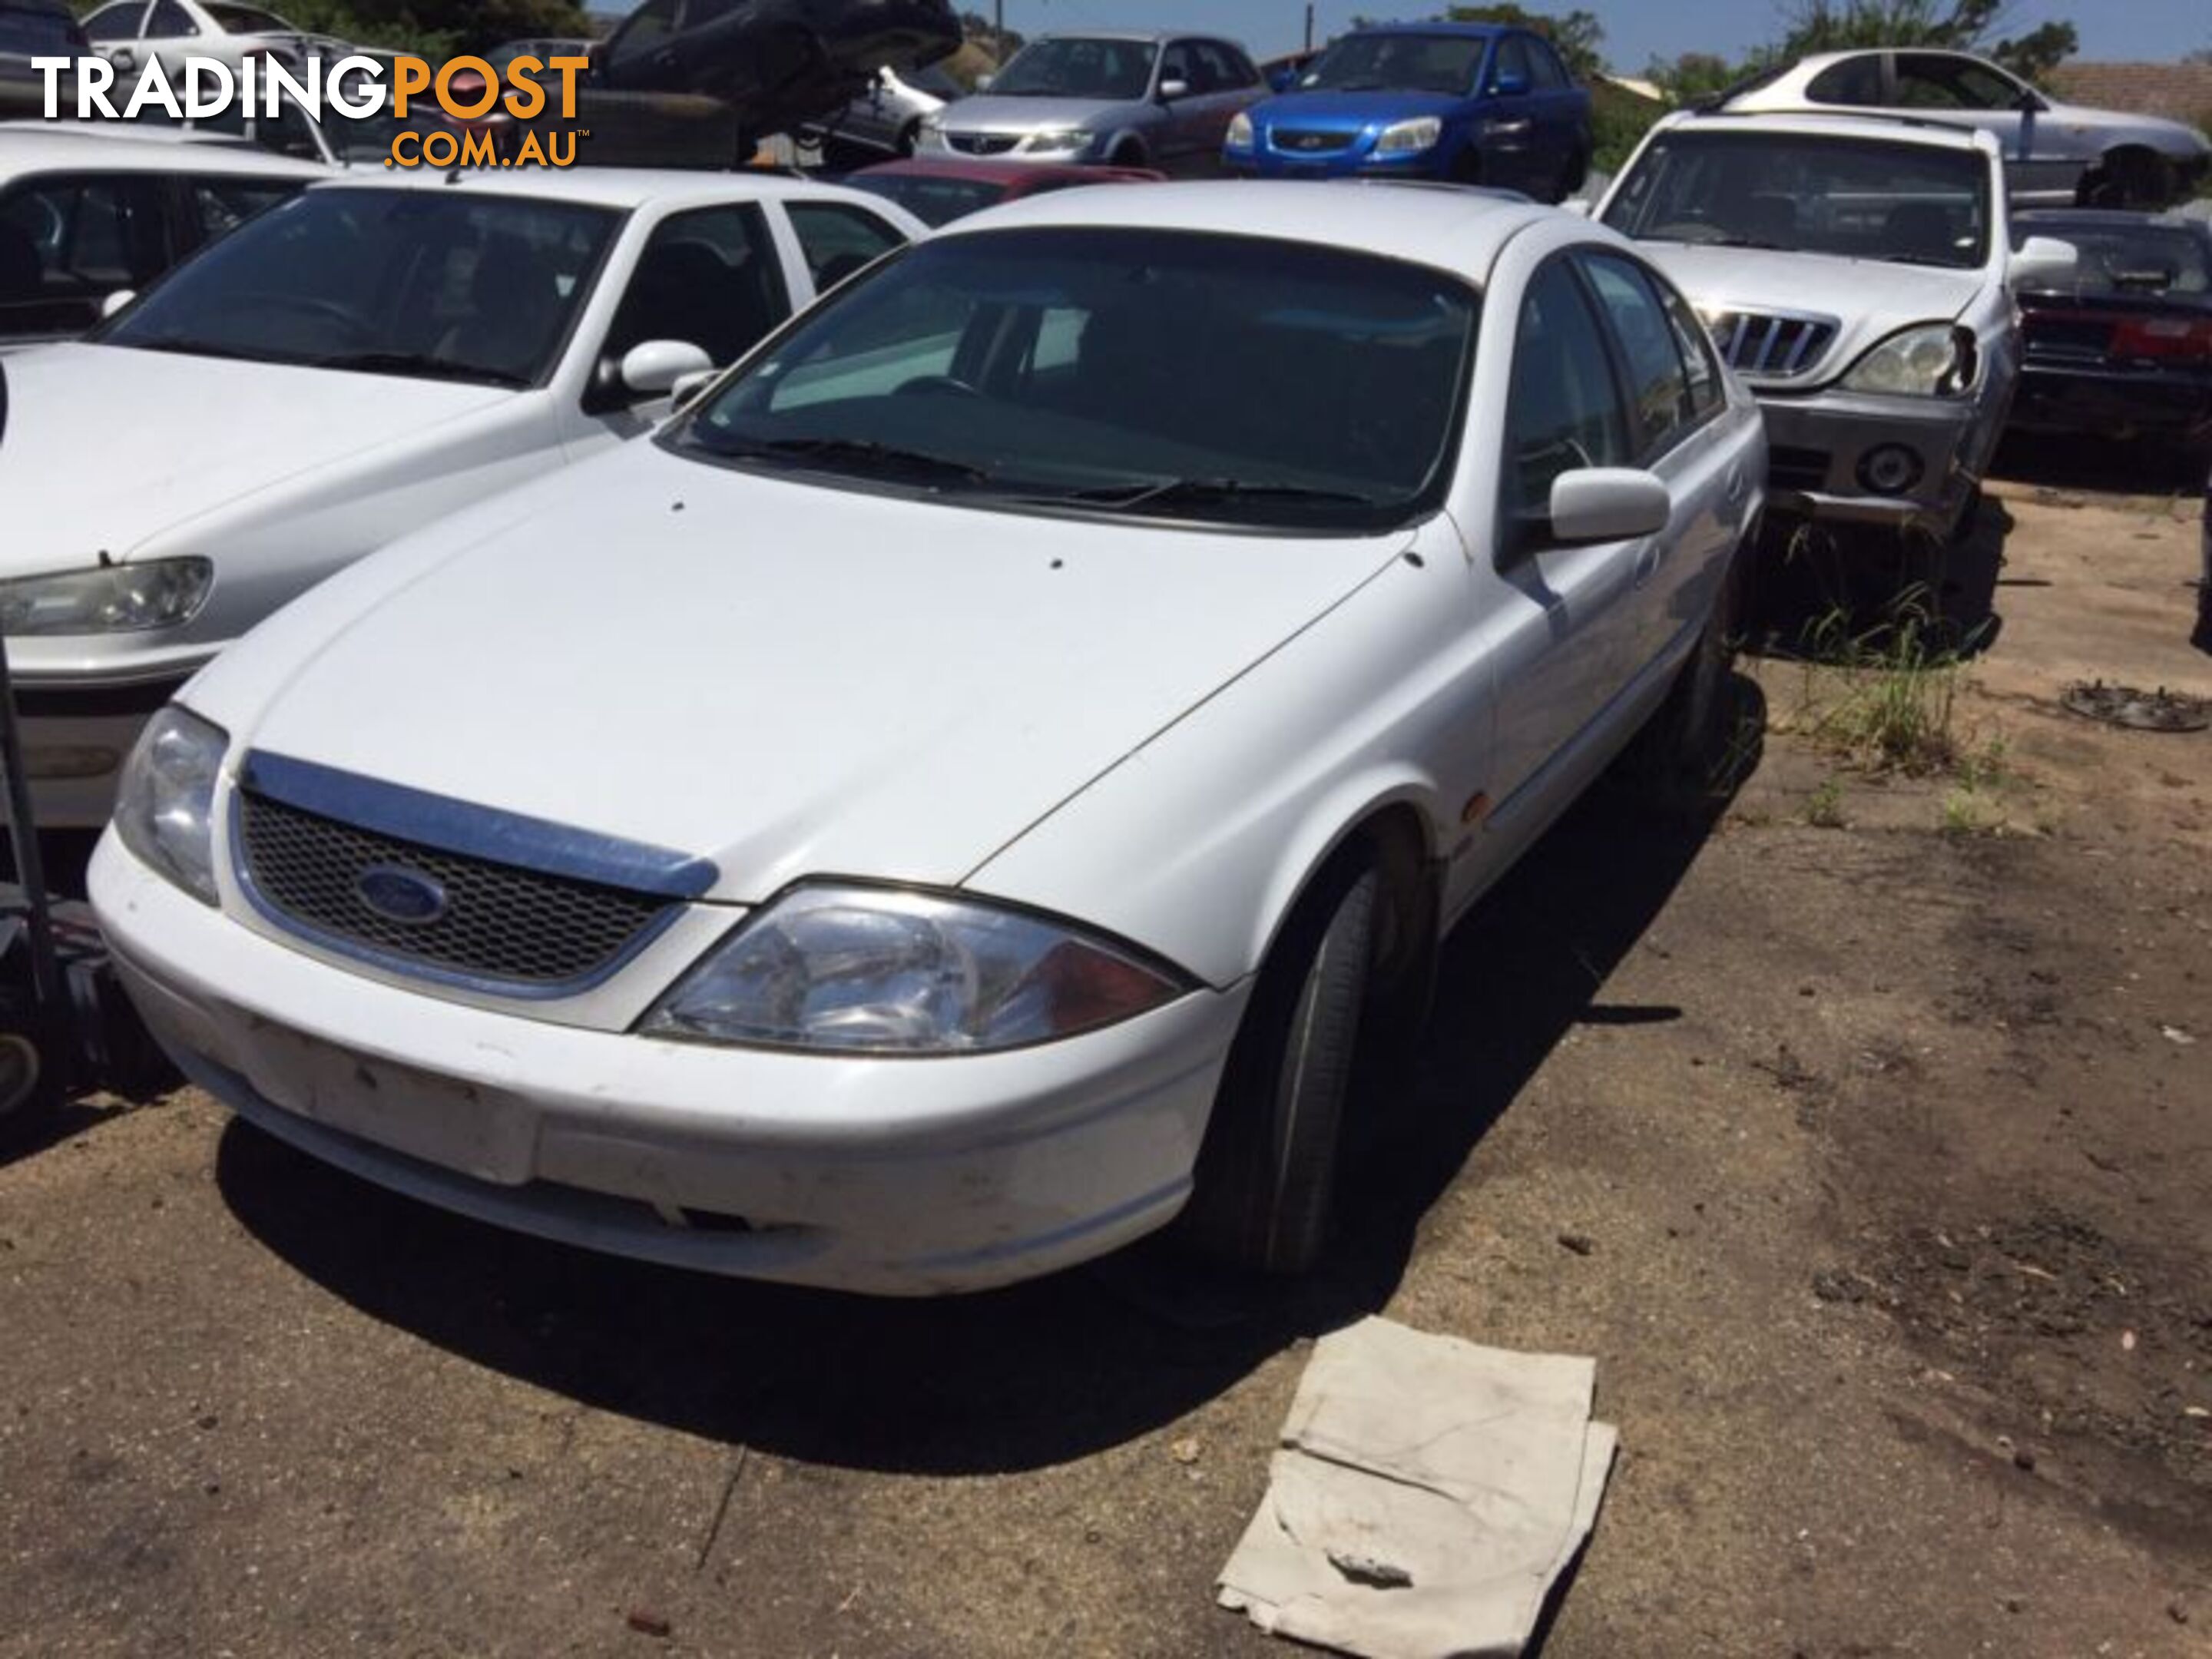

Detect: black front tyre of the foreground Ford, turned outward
[1184, 856, 1380, 1274]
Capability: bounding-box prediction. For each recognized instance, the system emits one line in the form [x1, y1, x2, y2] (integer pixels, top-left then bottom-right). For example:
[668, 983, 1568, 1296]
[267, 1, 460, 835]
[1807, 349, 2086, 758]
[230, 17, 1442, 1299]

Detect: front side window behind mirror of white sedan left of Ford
[604, 204, 792, 389]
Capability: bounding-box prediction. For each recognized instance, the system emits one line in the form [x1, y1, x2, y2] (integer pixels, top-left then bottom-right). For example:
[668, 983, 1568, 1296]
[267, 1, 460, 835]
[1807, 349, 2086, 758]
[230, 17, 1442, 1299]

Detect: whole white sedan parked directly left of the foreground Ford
[0, 162, 925, 825]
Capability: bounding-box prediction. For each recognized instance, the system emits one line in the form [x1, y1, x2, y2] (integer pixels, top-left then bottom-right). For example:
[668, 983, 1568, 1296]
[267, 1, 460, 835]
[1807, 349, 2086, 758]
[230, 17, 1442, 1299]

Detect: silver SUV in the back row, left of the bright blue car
[916, 28, 1267, 173]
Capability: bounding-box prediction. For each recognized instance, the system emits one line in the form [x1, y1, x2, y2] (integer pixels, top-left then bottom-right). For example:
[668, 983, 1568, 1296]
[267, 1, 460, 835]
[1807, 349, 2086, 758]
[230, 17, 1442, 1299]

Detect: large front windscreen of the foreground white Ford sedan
[673, 228, 1478, 531]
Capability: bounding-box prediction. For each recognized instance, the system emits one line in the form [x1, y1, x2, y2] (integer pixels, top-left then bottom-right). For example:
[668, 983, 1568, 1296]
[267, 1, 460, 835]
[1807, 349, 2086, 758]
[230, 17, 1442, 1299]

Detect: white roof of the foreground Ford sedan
[935, 179, 1566, 281]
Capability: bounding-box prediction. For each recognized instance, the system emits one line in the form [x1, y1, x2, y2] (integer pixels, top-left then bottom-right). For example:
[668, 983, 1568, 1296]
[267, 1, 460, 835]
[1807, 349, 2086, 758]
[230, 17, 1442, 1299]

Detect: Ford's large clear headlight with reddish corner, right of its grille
[639, 887, 1188, 1055]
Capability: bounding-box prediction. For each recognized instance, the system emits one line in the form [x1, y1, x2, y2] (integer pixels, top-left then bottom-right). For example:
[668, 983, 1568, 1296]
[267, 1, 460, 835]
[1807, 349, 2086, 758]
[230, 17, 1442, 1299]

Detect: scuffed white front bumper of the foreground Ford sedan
[91, 834, 1245, 1296]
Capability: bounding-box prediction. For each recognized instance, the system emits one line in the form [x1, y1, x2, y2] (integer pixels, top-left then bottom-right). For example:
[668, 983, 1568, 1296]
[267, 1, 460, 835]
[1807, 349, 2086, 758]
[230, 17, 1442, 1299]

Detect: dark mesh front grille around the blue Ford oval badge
[239, 790, 673, 991]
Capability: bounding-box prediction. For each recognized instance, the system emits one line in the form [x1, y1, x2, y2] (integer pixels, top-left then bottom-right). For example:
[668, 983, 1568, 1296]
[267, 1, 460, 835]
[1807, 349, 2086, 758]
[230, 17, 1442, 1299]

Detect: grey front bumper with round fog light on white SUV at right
[1754, 387, 1998, 535]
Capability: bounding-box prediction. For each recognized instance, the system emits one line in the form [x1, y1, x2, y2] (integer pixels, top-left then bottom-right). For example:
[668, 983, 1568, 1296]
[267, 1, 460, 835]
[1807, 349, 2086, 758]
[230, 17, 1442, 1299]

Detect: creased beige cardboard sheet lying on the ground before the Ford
[1221, 1318, 1617, 1659]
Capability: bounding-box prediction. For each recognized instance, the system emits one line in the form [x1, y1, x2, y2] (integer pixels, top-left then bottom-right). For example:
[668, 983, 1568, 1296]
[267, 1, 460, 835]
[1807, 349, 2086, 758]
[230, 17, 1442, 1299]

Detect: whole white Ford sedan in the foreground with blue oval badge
[93, 184, 1765, 1294]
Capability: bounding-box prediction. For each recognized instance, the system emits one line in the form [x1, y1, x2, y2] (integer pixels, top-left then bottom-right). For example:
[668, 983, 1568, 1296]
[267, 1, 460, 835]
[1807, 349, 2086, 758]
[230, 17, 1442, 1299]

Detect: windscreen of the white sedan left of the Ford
[93, 188, 619, 387]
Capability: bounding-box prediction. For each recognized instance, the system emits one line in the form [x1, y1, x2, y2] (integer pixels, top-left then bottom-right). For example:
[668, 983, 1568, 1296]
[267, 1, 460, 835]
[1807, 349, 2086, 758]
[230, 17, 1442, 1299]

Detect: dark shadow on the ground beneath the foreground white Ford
[217, 679, 1763, 1473]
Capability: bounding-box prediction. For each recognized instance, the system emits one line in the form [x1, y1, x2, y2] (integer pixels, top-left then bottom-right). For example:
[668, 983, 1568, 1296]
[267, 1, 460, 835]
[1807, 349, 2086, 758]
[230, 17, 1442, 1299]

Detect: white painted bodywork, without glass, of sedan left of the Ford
[0, 162, 925, 825]
